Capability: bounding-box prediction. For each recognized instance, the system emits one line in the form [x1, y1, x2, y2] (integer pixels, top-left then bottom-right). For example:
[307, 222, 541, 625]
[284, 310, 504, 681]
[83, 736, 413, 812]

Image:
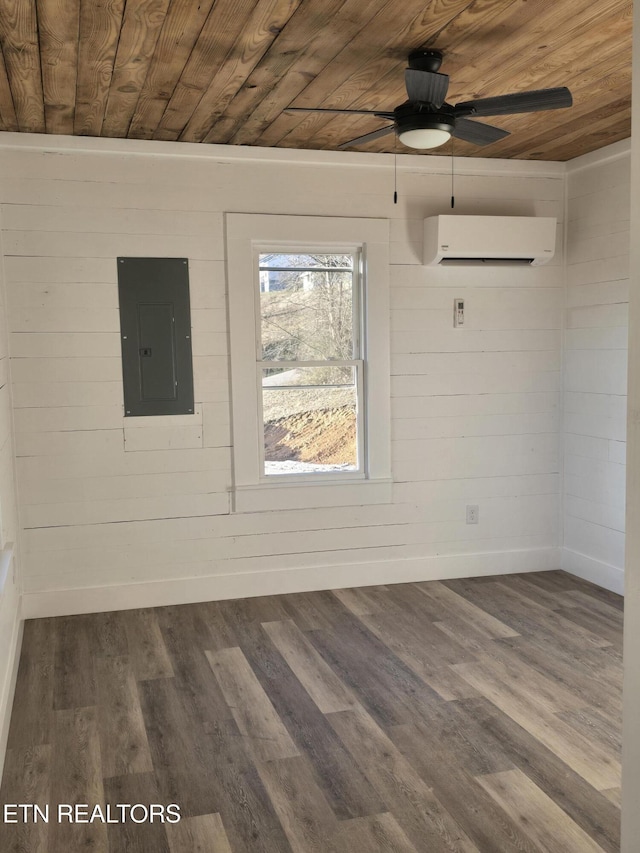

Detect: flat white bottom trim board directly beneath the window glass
[233, 480, 393, 512]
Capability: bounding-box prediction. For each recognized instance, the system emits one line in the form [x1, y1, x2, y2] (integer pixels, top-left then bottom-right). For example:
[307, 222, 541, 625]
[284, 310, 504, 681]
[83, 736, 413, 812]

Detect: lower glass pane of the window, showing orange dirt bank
[262, 367, 358, 475]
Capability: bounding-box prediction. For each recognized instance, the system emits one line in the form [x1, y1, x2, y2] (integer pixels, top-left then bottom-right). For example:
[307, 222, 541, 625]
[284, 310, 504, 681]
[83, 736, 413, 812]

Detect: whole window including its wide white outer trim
[227, 214, 390, 511]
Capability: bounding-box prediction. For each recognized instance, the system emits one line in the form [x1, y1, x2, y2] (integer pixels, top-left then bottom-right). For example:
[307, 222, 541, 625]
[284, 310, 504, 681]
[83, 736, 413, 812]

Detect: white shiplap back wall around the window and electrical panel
[0, 135, 564, 615]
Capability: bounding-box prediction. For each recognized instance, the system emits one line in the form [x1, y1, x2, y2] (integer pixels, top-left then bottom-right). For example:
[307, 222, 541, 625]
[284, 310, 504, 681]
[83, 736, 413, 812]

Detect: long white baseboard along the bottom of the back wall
[22, 548, 560, 619]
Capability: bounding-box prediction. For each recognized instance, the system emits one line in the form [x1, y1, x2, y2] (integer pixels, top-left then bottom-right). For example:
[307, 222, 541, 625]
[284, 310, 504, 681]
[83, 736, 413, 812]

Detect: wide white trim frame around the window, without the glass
[226, 213, 391, 512]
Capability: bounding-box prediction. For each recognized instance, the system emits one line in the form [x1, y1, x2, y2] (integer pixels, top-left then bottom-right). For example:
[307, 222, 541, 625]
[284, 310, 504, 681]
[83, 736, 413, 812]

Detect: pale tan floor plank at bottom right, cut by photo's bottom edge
[478, 770, 602, 853]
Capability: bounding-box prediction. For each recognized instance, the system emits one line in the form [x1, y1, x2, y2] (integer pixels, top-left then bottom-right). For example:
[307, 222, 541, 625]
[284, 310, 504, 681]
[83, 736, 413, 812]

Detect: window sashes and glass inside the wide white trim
[255, 249, 365, 479]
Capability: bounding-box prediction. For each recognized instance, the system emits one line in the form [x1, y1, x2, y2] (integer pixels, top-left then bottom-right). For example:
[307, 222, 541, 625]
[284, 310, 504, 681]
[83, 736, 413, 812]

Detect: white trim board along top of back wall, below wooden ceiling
[0, 131, 567, 178]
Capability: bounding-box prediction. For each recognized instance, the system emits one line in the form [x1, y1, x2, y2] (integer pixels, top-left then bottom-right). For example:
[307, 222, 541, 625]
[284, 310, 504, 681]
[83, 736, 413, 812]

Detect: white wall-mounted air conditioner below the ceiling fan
[424, 215, 556, 266]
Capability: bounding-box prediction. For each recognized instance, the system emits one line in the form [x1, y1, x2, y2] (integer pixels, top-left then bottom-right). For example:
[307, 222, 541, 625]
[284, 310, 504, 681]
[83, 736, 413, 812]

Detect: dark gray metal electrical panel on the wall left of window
[118, 258, 194, 417]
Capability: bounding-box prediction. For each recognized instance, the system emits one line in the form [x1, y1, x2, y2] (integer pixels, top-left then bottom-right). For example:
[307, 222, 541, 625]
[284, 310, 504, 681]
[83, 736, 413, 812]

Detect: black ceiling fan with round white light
[286, 50, 573, 149]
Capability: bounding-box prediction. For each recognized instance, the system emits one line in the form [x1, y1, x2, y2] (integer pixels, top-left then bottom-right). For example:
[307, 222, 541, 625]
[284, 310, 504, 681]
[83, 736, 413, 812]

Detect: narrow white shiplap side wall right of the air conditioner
[563, 140, 630, 592]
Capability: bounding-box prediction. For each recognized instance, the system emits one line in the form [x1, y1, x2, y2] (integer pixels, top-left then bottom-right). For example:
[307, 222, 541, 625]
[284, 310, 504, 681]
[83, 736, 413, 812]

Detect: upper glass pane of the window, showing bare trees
[260, 255, 356, 361]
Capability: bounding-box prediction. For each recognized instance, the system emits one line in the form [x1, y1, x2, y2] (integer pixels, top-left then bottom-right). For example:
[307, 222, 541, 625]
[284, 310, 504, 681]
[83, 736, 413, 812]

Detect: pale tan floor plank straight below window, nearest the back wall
[262, 621, 359, 713]
